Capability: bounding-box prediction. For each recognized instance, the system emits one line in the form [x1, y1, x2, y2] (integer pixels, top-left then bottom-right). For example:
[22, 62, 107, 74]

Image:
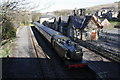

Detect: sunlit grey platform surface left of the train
[9, 26, 36, 58]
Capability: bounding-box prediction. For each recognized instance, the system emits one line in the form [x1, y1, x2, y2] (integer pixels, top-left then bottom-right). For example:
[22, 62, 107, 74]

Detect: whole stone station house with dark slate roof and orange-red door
[67, 15, 102, 40]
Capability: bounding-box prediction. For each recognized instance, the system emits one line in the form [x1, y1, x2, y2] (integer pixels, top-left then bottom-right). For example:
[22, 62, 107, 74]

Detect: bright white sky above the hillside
[0, 0, 120, 12]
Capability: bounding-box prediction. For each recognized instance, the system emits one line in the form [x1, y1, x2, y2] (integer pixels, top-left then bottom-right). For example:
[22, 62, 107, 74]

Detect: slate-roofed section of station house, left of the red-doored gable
[67, 16, 84, 39]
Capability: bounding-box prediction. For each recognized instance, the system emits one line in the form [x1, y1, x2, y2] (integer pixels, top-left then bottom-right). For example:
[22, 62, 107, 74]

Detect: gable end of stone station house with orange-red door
[80, 15, 102, 40]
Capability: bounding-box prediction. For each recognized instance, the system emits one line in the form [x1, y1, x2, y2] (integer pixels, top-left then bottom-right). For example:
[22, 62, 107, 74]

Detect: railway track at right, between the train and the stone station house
[76, 40, 120, 62]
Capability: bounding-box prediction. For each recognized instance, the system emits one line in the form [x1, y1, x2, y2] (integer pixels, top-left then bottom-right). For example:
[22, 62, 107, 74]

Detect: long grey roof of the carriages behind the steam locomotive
[34, 22, 60, 36]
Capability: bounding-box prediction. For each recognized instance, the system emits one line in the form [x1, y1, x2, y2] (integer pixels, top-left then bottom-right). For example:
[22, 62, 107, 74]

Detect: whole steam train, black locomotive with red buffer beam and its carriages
[34, 22, 86, 67]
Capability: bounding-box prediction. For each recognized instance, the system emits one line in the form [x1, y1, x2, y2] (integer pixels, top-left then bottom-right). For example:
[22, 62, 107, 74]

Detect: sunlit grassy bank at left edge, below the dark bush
[0, 38, 16, 57]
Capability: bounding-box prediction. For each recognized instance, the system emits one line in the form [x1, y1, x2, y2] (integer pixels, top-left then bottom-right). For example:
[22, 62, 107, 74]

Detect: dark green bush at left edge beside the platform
[2, 21, 16, 39]
